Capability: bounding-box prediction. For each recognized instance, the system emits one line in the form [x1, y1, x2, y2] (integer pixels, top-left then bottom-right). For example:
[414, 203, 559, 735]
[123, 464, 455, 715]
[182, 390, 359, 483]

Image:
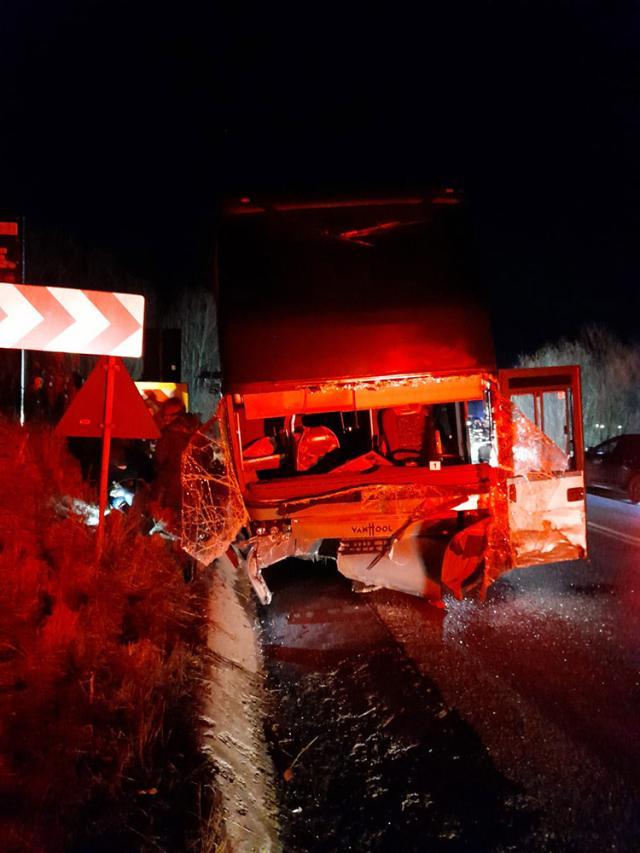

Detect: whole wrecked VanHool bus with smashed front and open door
[183, 190, 586, 602]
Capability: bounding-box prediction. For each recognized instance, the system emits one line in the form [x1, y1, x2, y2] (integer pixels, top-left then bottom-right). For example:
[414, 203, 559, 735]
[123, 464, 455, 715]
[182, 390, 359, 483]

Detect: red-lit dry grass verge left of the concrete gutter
[0, 424, 212, 851]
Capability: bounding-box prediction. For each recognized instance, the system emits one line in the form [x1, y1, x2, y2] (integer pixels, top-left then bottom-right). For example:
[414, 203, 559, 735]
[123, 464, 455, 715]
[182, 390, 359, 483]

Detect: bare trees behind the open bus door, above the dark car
[518, 325, 640, 446]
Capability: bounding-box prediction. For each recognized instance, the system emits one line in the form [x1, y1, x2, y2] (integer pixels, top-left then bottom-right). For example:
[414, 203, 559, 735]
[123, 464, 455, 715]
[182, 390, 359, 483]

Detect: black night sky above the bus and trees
[0, 0, 640, 362]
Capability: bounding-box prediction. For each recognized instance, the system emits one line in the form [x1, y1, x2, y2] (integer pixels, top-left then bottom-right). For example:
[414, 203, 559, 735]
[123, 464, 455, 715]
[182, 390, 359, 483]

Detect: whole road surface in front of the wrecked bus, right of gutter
[261, 495, 640, 851]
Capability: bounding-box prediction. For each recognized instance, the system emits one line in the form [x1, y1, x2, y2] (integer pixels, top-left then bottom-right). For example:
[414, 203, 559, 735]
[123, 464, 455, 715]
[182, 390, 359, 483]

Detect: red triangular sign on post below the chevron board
[56, 358, 160, 438]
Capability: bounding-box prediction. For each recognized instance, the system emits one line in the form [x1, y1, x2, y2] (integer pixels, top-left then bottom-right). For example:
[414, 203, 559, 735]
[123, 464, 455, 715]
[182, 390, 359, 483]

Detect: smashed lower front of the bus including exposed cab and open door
[185, 368, 586, 603]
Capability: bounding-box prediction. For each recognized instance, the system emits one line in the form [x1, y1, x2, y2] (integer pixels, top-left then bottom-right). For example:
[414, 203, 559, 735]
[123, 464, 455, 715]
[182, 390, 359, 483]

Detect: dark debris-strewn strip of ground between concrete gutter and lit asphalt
[261, 562, 544, 853]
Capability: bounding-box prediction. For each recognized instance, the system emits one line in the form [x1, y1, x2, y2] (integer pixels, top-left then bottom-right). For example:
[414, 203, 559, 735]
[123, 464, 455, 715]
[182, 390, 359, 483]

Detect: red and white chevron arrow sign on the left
[0, 282, 144, 358]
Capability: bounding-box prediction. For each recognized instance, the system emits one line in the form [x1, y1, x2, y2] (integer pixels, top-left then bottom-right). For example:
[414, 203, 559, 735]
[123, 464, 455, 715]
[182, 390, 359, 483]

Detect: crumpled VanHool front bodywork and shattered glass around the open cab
[183, 370, 586, 603]
